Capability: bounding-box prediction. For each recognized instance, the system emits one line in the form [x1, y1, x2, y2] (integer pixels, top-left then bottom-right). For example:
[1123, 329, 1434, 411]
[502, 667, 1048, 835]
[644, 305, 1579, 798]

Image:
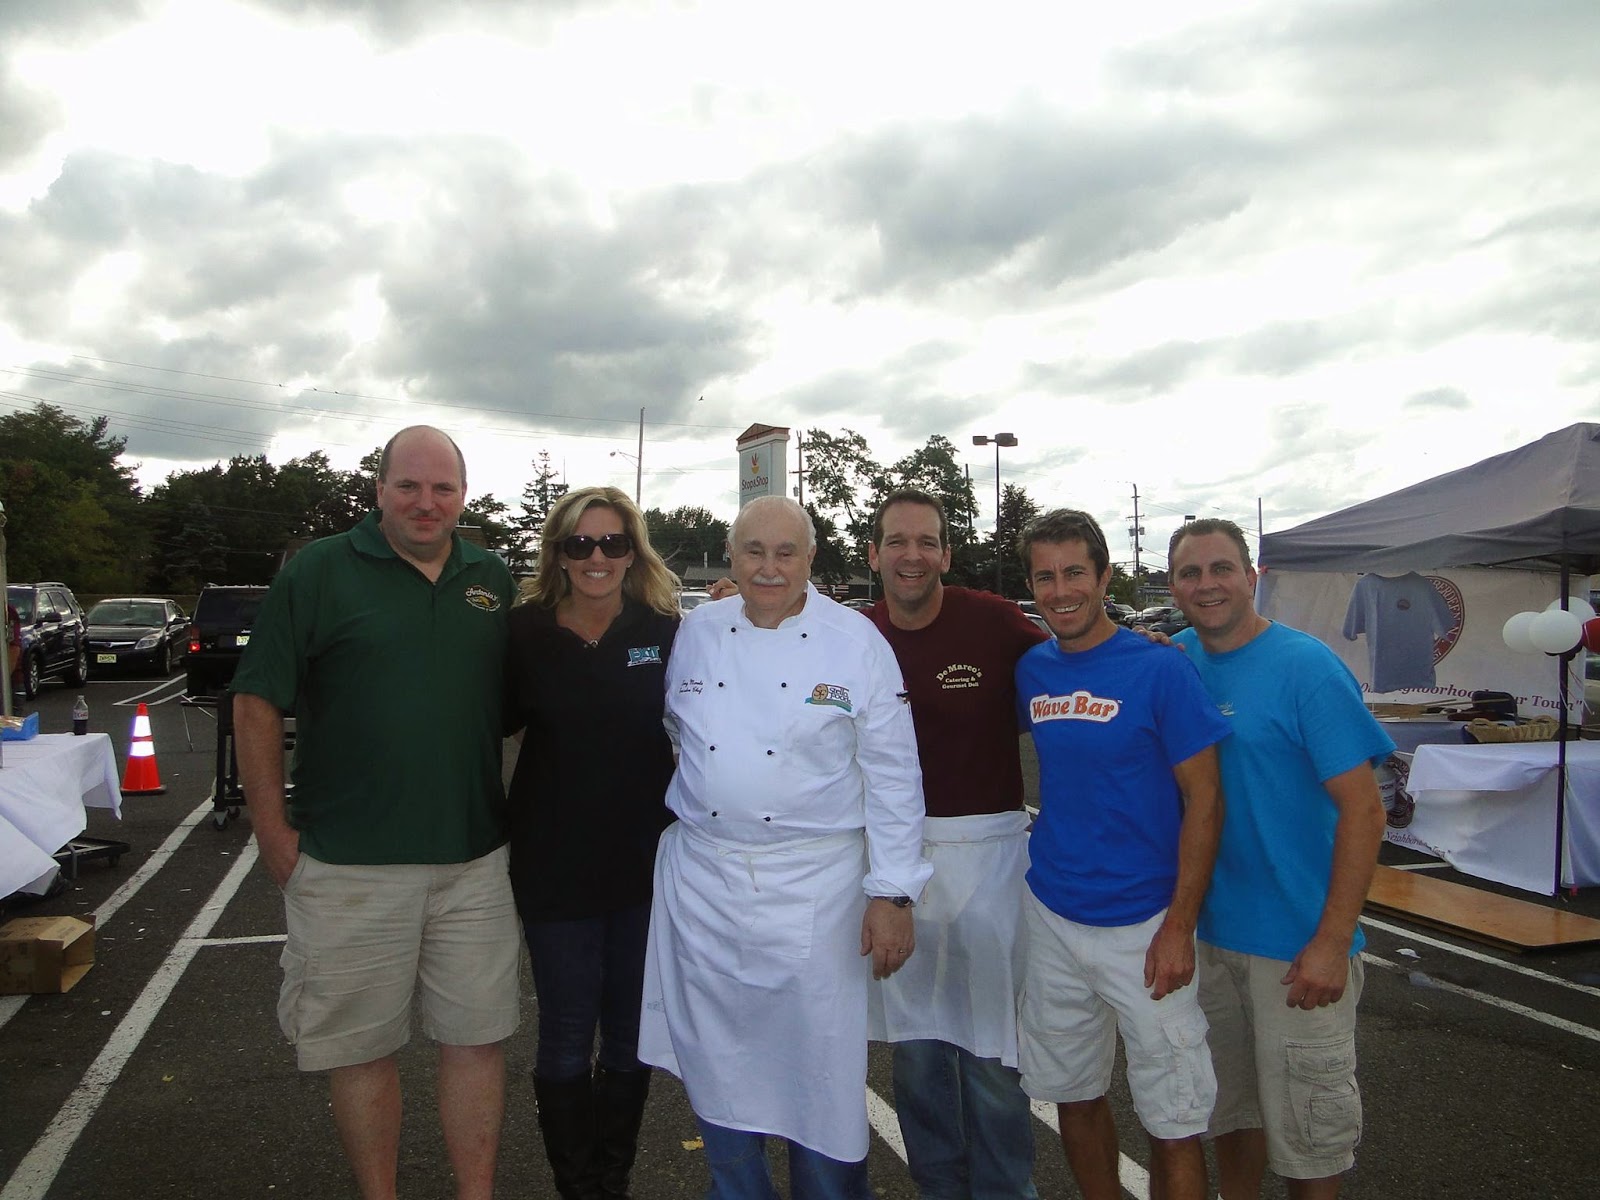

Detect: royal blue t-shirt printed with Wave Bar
[1016, 629, 1227, 926]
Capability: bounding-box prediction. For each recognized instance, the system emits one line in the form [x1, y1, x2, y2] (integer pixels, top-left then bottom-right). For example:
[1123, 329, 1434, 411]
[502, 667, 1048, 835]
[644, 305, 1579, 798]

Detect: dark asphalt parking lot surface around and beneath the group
[0, 678, 1600, 1200]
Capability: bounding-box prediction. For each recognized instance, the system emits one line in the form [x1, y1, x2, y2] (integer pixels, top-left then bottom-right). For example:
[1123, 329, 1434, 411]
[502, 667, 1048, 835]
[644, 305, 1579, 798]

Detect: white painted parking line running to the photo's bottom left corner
[0, 838, 256, 1200]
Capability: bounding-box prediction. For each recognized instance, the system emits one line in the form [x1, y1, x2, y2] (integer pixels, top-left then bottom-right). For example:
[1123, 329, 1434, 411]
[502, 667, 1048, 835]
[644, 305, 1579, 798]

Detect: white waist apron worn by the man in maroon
[867, 811, 1027, 1067]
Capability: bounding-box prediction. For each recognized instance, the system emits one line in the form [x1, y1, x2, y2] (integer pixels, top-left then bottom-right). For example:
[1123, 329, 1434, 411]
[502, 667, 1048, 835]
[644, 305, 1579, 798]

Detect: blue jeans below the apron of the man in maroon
[894, 1042, 1038, 1200]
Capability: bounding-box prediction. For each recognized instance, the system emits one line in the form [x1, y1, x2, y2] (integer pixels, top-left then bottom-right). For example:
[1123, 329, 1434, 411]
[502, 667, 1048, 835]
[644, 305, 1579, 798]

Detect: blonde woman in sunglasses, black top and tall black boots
[506, 488, 678, 1198]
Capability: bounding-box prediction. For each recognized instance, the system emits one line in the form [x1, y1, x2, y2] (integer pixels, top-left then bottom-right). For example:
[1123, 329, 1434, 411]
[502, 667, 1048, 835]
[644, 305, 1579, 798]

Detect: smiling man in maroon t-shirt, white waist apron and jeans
[867, 490, 1048, 1200]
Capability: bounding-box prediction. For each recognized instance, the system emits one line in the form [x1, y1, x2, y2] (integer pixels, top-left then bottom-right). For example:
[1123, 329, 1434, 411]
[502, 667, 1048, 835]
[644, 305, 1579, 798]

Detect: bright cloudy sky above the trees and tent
[0, 0, 1600, 562]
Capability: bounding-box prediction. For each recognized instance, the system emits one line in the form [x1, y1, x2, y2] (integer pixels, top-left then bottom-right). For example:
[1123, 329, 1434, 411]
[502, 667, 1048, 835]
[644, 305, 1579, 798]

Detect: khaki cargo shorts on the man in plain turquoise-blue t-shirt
[1200, 942, 1363, 1179]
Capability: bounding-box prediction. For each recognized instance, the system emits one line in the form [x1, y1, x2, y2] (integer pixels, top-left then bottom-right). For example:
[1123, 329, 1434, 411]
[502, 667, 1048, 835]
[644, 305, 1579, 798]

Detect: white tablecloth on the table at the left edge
[0, 733, 122, 896]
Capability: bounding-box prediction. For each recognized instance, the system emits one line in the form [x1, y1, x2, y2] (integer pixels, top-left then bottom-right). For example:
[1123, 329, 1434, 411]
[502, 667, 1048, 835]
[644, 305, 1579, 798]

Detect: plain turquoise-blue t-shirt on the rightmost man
[1173, 624, 1394, 962]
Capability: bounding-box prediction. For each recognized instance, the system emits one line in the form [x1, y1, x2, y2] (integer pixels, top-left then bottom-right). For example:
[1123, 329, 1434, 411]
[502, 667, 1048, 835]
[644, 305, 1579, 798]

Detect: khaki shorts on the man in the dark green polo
[278, 846, 522, 1070]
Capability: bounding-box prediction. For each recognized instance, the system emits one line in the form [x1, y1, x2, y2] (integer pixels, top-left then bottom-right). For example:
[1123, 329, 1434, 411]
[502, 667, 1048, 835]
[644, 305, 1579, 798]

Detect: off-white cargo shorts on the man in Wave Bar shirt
[1018, 890, 1216, 1141]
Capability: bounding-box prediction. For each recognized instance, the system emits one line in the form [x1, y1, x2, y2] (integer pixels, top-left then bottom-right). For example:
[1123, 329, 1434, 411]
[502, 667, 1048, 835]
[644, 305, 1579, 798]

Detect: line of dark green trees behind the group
[0, 403, 1131, 597]
